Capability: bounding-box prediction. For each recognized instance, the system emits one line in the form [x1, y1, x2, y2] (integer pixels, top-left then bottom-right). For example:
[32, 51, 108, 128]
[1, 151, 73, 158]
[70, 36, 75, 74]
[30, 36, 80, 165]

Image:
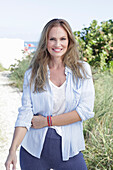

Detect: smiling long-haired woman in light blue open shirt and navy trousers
[5, 19, 94, 170]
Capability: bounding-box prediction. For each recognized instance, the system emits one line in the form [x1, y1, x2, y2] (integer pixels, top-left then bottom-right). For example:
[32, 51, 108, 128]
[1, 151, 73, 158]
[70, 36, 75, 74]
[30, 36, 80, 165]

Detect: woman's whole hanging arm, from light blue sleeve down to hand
[5, 70, 33, 170]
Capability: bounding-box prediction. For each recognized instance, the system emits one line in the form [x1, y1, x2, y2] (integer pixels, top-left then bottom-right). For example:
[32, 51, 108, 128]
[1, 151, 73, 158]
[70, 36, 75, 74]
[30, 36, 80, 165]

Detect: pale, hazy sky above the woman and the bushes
[0, 0, 113, 41]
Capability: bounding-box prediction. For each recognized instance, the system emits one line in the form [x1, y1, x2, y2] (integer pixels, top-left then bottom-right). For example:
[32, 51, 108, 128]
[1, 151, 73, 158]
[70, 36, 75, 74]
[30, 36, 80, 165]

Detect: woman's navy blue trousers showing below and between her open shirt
[20, 128, 87, 170]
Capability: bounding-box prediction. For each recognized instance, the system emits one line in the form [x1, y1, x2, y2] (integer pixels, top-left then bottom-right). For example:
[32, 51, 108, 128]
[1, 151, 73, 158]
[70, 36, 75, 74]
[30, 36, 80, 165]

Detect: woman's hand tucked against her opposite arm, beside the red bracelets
[31, 115, 47, 129]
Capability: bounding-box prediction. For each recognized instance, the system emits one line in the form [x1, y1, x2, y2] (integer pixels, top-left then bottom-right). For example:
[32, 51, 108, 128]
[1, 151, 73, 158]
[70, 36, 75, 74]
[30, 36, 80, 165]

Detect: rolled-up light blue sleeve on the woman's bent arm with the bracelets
[76, 64, 95, 121]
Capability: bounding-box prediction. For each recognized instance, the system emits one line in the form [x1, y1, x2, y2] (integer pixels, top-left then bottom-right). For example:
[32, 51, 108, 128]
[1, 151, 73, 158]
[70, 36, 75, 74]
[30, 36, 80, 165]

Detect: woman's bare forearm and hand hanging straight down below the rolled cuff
[5, 127, 27, 170]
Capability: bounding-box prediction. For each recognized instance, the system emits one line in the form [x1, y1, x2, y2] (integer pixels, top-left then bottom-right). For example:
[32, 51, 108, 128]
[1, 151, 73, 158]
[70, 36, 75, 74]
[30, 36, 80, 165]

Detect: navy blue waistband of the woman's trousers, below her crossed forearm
[46, 128, 61, 139]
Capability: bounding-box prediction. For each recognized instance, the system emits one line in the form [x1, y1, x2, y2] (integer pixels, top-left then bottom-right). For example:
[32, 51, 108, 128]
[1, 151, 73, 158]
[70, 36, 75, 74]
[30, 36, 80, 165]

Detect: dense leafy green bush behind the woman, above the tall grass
[74, 19, 113, 71]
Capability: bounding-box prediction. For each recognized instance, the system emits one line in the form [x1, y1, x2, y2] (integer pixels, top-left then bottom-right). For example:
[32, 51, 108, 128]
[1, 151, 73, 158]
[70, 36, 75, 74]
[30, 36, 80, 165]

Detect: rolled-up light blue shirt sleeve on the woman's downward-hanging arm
[15, 71, 33, 130]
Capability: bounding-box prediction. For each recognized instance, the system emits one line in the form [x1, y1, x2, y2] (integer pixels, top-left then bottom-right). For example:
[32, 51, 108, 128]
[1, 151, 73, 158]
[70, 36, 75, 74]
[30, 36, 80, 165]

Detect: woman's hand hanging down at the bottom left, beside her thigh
[5, 151, 17, 170]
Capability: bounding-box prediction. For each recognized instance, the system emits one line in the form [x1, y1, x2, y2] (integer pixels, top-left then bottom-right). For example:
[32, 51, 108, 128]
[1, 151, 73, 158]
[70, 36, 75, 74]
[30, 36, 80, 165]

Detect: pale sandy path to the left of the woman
[0, 71, 22, 170]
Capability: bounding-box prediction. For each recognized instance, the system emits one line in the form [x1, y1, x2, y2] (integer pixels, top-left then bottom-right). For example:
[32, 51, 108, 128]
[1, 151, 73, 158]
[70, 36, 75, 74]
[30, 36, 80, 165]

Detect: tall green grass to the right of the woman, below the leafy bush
[84, 71, 113, 170]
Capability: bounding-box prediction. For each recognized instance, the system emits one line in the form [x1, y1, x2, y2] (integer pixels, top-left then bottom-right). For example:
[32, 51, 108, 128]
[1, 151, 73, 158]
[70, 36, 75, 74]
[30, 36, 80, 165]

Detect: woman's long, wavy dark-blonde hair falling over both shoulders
[29, 19, 85, 92]
